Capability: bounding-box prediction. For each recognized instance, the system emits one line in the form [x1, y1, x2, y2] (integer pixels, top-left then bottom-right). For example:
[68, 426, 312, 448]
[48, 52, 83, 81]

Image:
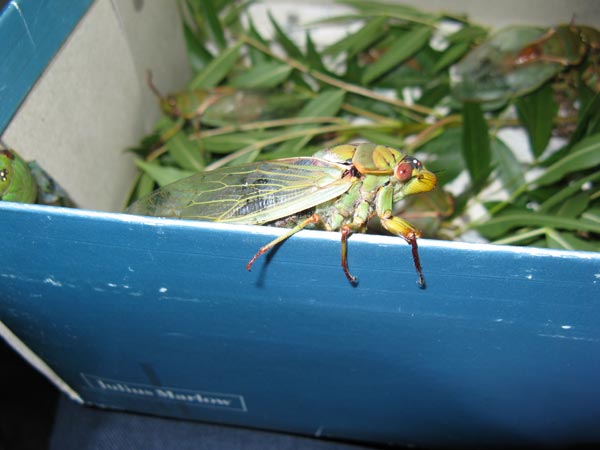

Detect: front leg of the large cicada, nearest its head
[376, 185, 425, 289]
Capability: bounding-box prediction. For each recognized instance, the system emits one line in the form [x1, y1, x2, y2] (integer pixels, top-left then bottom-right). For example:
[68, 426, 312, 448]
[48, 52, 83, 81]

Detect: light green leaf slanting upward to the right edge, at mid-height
[535, 133, 600, 186]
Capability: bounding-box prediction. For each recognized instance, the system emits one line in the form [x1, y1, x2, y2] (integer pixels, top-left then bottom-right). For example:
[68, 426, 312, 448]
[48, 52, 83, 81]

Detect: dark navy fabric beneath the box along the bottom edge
[50, 397, 376, 450]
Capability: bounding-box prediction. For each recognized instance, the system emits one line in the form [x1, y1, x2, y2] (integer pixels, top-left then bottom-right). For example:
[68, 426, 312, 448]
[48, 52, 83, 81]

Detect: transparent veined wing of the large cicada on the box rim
[126, 158, 352, 224]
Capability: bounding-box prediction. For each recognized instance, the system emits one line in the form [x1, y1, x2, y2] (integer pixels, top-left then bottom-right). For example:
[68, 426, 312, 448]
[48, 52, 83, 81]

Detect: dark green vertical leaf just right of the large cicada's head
[462, 102, 492, 187]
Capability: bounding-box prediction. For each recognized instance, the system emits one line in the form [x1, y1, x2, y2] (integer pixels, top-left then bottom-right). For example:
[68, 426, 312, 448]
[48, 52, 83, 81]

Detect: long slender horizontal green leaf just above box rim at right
[476, 212, 600, 238]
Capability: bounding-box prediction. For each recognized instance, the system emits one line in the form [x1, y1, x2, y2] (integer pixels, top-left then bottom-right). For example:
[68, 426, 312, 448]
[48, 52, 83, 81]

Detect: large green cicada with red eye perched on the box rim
[126, 144, 437, 288]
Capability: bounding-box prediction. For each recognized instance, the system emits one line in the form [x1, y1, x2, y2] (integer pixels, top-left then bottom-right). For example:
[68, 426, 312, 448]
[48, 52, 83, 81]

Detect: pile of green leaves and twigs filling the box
[128, 0, 600, 250]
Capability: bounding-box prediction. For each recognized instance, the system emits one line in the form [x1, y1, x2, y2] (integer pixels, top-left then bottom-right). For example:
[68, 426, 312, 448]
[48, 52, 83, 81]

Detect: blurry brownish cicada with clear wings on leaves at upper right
[452, 24, 600, 101]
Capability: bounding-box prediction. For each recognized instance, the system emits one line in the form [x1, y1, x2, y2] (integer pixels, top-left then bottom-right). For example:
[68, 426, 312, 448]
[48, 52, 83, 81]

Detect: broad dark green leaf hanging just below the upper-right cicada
[515, 83, 558, 158]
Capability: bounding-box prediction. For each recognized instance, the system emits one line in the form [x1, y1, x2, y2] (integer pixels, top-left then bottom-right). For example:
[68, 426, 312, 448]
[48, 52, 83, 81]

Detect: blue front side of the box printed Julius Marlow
[0, 2, 600, 448]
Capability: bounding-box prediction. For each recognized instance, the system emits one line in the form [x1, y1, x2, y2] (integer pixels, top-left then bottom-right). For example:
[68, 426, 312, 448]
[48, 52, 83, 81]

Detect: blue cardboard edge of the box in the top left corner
[0, 0, 93, 133]
